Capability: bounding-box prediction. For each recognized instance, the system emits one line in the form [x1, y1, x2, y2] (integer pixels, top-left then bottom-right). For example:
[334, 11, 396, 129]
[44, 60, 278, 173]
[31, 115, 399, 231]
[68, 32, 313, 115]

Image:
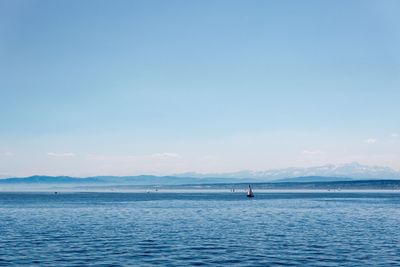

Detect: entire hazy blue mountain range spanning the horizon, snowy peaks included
[0, 163, 400, 186]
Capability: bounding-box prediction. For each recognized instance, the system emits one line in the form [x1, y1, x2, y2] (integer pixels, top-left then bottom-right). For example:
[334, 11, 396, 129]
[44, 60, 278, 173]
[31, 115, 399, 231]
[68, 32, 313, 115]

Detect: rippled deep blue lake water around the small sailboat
[0, 193, 400, 266]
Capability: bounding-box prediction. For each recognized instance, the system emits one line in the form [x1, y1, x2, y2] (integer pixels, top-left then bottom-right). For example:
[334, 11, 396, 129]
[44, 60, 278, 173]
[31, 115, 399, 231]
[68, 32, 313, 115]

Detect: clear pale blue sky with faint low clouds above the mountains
[0, 0, 400, 177]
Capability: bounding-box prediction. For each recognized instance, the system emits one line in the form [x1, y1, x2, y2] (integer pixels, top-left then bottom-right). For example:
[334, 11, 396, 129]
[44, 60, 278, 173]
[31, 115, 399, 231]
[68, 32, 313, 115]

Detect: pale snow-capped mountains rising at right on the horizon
[177, 162, 400, 180]
